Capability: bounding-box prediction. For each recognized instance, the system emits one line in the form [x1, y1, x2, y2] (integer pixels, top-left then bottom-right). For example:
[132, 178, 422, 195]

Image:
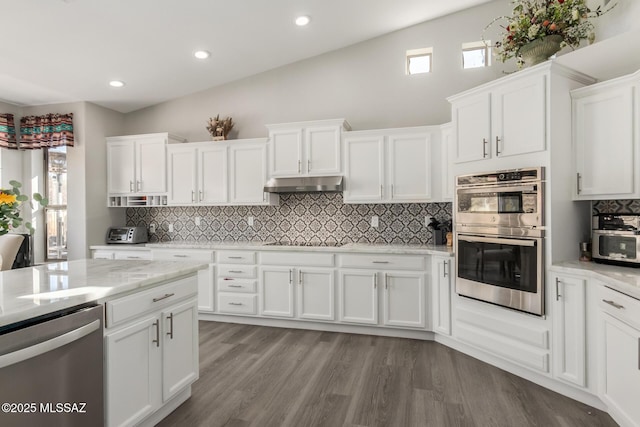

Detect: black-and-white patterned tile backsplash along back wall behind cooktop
[127, 193, 451, 244]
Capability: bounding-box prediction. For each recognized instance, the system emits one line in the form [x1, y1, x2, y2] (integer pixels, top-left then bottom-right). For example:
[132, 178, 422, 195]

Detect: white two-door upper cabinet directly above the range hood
[267, 119, 351, 177]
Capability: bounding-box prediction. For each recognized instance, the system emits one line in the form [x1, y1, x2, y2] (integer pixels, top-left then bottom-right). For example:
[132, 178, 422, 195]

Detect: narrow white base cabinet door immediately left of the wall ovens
[431, 257, 451, 335]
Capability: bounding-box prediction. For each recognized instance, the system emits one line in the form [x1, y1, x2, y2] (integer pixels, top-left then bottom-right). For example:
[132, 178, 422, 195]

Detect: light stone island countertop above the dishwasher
[0, 259, 208, 328]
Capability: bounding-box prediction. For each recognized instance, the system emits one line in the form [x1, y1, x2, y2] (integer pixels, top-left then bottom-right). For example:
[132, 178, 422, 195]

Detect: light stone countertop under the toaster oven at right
[551, 261, 640, 299]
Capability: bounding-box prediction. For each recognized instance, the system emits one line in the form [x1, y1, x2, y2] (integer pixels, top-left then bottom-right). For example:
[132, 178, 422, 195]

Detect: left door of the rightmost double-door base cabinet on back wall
[338, 270, 379, 325]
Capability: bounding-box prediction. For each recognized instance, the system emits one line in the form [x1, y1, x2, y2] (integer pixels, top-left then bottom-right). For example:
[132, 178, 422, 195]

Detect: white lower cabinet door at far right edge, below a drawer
[604, 314, 640, 426]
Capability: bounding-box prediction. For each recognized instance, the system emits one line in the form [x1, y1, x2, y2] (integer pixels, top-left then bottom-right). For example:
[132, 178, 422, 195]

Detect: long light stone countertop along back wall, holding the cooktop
[90, 241, 453, 256]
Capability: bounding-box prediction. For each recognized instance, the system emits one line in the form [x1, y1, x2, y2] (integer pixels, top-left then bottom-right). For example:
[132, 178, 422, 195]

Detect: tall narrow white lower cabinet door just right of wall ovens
[552, 276, 587, 387]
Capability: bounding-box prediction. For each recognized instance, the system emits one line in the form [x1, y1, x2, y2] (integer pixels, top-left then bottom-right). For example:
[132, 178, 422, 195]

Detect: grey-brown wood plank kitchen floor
[159, 321, 616, 427]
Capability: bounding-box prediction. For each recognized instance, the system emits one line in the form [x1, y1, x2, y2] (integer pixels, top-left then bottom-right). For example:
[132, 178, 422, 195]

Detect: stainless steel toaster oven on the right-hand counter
[591, 213, 640, 267]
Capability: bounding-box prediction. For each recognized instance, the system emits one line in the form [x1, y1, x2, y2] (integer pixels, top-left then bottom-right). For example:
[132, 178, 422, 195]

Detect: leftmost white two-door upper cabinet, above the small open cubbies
[107, 133, 184, 195]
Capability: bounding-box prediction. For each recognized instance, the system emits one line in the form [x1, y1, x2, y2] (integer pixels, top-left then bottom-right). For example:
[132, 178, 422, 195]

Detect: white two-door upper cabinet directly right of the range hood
[344, 127, 433, 203]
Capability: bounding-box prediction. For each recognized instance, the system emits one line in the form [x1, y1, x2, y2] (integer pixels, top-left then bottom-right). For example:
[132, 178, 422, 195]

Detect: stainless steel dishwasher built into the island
[0, 306, 104, 427]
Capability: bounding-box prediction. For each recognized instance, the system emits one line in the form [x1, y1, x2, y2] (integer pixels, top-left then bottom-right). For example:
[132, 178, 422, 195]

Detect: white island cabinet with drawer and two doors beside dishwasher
[105, 277, 199, 427]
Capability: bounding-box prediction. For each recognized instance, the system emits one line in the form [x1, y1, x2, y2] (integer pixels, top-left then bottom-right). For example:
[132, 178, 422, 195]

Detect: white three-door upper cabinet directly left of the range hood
[167, 139, 278, 206]
